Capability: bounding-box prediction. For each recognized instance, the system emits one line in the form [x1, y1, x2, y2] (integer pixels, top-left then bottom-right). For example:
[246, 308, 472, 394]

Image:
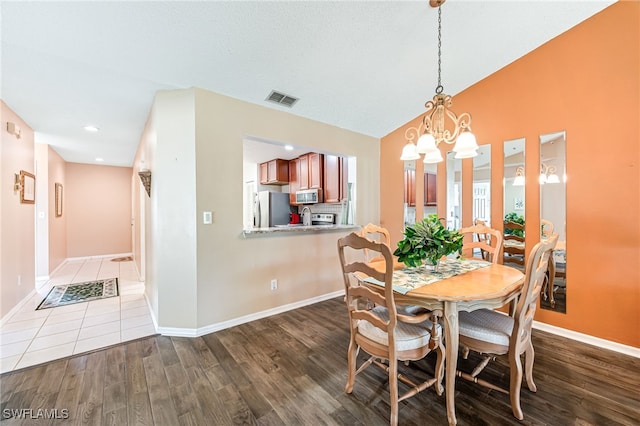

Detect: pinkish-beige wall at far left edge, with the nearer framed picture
[0, 101, 35, 318]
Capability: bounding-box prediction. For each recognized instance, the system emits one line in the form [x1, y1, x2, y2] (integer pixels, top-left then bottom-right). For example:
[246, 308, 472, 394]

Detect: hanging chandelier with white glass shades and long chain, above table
[400, 0, 478, 163]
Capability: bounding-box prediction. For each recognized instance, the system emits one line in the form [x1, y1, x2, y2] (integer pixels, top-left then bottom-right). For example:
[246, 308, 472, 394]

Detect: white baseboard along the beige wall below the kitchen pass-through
[156, 290, 344, 337]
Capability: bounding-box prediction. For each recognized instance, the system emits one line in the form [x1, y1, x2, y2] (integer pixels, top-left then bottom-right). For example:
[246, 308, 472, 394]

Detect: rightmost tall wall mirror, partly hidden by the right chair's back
[539, 132, 567, 313]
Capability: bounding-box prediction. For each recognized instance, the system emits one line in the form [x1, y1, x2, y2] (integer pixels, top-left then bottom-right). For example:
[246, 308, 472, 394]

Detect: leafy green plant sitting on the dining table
[393, 214, 463, 267]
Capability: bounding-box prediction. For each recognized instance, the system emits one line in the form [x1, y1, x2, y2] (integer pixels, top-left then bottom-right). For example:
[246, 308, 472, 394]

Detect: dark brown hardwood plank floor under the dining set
[0, 298, 640, 426]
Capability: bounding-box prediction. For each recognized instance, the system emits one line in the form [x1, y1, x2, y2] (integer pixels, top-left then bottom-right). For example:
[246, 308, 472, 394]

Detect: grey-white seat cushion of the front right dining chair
[458, 309, 513, 346]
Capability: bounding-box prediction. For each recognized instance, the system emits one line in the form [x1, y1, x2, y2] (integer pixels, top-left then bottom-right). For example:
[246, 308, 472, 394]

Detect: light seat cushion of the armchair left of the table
[358, 306, 441, 351]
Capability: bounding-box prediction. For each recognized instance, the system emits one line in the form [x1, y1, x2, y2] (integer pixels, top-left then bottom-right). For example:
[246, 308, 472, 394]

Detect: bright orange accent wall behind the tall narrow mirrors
[380, 1, 640, 347]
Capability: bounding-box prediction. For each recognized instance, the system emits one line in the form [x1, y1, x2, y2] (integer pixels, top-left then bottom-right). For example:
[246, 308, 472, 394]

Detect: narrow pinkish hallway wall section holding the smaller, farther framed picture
[47, 146, 69, 272]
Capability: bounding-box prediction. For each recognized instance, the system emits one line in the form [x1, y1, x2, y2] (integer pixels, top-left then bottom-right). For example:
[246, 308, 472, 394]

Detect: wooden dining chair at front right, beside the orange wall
[457, 234, 558, 420]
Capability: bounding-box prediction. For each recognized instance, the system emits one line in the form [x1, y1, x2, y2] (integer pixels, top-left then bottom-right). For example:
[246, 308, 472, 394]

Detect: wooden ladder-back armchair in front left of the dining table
[338, 232, 444, 425]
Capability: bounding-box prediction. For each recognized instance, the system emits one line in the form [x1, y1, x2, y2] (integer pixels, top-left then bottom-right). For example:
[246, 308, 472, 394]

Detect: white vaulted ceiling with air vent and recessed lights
[0, 0, 613, 166]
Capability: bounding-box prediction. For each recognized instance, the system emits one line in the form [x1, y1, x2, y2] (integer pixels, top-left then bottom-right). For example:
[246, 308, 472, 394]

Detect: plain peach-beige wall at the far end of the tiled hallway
[65, 163, 132, 258]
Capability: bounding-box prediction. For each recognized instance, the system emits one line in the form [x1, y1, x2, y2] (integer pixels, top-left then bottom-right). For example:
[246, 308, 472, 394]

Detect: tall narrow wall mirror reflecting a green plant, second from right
[502, 138, 525, 270]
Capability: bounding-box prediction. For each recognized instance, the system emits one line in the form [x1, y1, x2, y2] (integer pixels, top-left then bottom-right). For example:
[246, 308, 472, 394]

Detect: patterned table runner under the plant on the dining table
[363, 259, 491, 294]
